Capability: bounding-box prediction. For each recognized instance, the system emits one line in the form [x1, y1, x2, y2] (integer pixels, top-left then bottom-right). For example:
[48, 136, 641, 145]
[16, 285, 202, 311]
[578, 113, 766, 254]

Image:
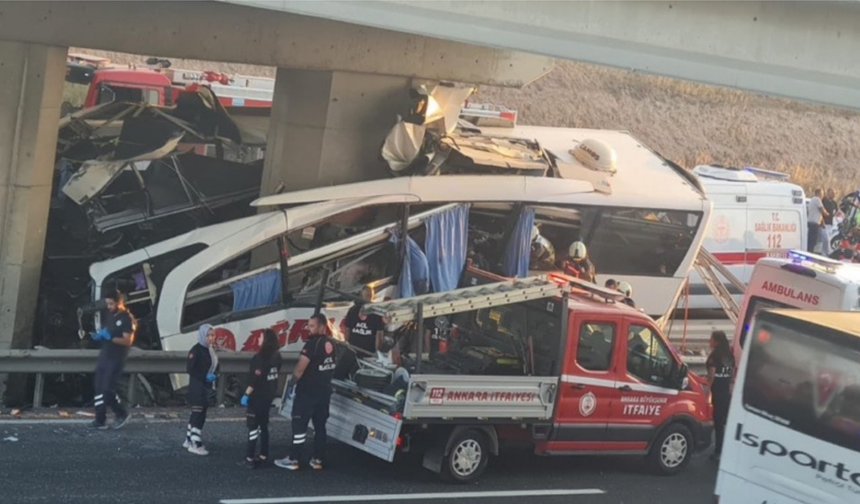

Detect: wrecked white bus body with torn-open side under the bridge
[90, 128, 711, 386]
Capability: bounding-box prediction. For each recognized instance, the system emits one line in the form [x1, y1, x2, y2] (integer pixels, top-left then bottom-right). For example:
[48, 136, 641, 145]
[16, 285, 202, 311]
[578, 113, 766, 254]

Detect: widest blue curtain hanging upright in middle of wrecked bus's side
[424, 205, 469, 292]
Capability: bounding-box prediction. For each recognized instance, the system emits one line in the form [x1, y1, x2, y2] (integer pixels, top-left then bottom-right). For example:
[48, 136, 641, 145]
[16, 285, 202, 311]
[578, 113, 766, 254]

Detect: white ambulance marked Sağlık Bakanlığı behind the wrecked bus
[689, 165, 807, 309]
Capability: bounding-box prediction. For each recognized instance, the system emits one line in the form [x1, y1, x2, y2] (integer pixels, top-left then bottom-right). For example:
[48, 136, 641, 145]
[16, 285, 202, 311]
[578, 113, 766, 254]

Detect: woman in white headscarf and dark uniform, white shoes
[182, 324, 218, 455]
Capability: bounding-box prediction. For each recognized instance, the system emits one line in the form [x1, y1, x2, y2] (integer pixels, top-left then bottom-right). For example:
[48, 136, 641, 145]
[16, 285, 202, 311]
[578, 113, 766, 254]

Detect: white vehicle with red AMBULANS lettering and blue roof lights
[732, 250, 860, 360]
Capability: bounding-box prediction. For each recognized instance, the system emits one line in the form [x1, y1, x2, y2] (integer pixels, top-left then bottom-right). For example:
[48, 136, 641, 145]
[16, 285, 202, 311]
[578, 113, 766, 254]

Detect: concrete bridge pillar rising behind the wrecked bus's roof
[262, 68, 411, 195]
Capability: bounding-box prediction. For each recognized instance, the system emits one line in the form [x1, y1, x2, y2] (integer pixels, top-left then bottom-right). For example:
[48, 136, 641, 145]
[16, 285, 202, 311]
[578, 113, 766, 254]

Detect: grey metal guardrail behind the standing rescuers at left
[0, 348, 298, 408]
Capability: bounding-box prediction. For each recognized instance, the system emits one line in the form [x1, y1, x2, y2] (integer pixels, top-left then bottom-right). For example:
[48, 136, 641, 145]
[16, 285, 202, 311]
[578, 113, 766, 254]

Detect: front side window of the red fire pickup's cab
[627, 324, 674, 387]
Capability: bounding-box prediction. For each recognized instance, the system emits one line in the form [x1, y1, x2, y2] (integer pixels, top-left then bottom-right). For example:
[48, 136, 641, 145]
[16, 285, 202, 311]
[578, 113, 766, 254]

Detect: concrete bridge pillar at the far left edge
[0, 41, 67, 404]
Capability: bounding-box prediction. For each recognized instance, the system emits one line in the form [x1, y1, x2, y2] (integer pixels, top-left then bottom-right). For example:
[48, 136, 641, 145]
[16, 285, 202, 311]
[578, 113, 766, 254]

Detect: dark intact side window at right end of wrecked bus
[585, 208, 701, 277]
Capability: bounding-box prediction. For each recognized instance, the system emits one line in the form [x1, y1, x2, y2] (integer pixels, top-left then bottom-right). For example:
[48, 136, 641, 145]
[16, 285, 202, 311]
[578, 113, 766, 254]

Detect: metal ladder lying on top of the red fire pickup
[364, 276, 562, 324]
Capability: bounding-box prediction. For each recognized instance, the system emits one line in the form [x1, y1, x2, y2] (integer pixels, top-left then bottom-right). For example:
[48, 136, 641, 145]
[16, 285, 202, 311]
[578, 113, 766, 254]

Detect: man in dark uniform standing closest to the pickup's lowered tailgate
[275, 313, 337, 471]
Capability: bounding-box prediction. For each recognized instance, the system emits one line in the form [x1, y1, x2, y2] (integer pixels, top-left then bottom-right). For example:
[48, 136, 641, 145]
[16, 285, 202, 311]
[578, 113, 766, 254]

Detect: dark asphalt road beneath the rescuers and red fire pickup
[0, 419, 716, 504]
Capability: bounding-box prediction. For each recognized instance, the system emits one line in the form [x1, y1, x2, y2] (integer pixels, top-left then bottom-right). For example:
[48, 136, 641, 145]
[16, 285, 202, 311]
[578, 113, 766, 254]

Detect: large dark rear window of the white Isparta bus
[743, 322, 860, 452]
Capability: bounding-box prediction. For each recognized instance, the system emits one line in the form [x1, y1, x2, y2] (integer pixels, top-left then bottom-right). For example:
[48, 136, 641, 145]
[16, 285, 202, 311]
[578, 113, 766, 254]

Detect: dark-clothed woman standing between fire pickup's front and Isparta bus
[705, 331, 735, 460]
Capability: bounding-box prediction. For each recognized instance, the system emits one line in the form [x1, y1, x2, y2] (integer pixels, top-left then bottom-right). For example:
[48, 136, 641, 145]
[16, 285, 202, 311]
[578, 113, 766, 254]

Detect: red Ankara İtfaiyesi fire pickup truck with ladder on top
[282, 268, 713, 482]
